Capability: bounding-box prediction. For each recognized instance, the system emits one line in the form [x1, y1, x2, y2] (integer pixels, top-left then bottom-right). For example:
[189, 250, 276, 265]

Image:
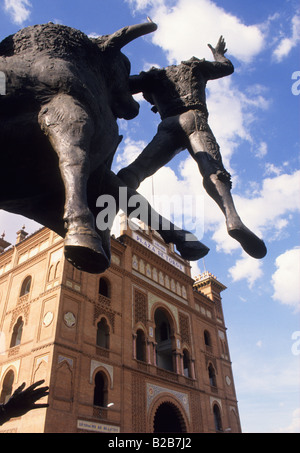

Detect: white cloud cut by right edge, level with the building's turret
[272, 247, 300, 312]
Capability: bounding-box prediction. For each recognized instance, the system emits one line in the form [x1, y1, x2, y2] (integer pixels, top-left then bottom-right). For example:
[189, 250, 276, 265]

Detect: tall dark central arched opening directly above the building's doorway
[154, 308, 174, 371]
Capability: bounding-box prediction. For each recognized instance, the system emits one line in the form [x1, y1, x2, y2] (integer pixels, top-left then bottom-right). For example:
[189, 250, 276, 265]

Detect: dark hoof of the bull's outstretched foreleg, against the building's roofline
[160, 230, 209, 261]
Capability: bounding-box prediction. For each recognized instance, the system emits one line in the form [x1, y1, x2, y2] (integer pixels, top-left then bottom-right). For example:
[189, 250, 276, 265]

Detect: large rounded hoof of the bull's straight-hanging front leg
[65, 231, 110, 274]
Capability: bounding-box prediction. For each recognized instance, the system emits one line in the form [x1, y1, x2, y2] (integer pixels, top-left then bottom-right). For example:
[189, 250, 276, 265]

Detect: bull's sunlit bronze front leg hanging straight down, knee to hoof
[39, 94, 109, 273]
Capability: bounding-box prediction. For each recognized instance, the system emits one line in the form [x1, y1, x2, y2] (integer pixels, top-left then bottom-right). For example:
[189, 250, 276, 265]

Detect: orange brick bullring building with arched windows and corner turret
[0, 220, 241, 433]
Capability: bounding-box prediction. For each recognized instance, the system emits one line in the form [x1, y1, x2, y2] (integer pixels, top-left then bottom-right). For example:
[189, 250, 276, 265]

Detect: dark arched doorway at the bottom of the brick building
[153, 403, 187, 433]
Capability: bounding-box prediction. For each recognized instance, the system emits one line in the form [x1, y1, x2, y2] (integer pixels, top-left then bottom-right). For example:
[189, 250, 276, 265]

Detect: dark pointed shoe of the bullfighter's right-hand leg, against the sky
[228, 225, 267, 259]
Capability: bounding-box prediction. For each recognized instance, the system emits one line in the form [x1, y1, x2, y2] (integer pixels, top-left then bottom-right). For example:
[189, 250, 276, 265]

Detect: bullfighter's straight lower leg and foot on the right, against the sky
[189, 126, 267, 258]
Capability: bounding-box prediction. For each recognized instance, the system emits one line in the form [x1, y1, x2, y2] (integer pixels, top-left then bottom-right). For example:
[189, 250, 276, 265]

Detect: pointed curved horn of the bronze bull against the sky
[105, 18, 157, 50]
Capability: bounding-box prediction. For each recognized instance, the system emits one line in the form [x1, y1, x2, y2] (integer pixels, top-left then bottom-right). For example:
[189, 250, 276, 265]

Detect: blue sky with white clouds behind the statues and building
[0, 0, 300, 433]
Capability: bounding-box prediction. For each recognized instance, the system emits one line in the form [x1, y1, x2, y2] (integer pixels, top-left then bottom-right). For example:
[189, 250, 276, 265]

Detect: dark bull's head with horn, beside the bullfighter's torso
[94, 18, 157, 120]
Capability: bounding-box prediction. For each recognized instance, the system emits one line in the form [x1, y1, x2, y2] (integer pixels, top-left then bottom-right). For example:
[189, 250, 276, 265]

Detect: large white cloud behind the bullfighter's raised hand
[129, 0, 264, 63]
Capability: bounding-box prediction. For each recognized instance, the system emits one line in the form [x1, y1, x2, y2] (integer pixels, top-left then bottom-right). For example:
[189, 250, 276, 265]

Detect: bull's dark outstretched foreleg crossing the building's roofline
[105, 171, 209, 261]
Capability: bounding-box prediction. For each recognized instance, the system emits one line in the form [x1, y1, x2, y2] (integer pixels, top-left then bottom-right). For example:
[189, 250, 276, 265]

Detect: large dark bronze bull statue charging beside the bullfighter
[0, 20, 208, 273]
